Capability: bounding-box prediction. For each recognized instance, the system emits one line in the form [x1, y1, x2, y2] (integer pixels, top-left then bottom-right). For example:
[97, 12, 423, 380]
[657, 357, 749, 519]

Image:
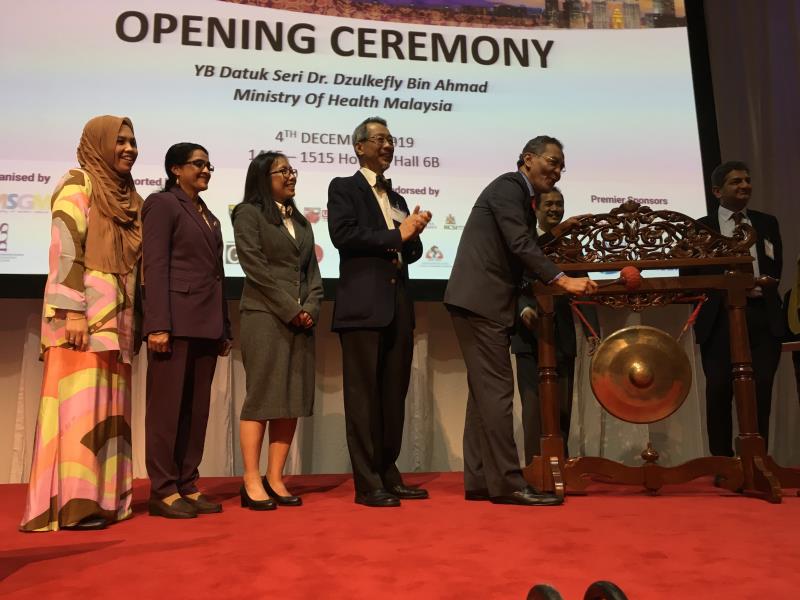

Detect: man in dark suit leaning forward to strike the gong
[444, 136, 597, 506]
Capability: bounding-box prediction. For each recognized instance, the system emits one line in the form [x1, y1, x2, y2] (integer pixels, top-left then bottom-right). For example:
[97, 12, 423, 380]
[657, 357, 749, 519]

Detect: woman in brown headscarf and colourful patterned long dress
[20, 116, 142, 531]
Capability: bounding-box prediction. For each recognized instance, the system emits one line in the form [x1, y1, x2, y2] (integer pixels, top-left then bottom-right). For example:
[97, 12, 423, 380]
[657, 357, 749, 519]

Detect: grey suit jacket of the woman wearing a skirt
[232, 203, 322, 323]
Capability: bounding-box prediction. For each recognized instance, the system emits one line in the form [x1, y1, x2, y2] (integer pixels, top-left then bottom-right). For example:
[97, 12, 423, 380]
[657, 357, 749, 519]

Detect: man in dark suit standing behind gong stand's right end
[694, 161, 784, 456]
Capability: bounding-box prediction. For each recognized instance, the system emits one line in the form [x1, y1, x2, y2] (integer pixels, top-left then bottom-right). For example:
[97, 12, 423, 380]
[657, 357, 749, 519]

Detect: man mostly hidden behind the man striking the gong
[511, 187, 600, 464]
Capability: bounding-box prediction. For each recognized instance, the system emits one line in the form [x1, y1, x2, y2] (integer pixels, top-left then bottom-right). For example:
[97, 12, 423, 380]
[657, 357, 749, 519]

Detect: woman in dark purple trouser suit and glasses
[142, 143, 231, 519]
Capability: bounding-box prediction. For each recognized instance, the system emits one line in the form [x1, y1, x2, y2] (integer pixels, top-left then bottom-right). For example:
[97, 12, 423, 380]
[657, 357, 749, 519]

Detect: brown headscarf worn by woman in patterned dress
[78, 115, 142, 274]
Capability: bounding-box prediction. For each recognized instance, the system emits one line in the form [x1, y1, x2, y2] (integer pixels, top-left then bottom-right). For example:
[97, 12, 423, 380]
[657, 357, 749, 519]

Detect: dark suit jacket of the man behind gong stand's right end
[681, 208, 785, 344]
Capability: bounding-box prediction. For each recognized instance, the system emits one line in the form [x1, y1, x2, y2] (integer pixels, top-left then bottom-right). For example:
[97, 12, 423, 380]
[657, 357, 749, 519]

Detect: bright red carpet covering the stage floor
[0, 473, 800, 600]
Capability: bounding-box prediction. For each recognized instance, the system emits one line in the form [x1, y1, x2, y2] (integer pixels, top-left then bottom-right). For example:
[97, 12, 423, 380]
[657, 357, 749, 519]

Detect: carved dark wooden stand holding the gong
[523, 201, 800, 503]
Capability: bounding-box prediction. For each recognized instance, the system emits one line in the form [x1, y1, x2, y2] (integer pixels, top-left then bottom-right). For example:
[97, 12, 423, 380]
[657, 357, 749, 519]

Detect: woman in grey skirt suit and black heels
[232, 152, 322, 510]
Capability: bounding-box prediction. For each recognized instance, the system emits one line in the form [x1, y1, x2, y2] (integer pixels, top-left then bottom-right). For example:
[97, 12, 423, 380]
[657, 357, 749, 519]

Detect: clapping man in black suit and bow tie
[328, 117, 431, 507]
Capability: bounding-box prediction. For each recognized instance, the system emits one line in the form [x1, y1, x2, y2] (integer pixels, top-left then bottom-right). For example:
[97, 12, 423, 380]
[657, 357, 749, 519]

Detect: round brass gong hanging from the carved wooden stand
[591, 325, 692, 423]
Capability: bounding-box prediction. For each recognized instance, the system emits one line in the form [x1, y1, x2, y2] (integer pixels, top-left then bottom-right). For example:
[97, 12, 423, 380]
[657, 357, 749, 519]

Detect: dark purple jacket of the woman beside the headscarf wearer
[142, 186, 231, 340]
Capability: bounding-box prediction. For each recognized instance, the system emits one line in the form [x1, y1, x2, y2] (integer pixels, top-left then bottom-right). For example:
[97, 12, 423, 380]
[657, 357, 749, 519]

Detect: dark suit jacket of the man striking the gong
[444, 171, 559, 328]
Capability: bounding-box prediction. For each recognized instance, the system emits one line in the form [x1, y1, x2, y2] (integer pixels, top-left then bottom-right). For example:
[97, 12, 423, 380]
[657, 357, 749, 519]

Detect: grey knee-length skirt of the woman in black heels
[240, 310, 315, 421]
